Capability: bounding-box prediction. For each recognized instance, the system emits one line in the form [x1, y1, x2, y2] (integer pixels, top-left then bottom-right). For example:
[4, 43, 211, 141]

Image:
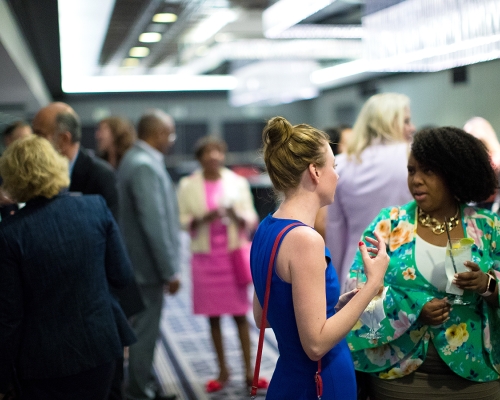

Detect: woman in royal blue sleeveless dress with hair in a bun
[251, 117, 389, 400]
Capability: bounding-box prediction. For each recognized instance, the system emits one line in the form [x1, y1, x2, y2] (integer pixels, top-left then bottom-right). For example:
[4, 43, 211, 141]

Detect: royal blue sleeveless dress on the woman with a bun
[250, 215, 356, 400]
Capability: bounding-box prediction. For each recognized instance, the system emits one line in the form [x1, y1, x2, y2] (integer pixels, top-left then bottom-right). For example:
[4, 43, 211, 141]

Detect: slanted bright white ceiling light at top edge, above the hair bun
[262, 0, 335, 38]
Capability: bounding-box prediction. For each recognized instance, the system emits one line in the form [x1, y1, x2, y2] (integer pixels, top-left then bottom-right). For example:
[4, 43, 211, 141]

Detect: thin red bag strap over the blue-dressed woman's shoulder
[250, 222, 323, 400]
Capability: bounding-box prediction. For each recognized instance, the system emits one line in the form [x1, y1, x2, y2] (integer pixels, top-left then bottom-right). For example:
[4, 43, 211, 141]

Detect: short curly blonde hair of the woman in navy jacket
[0, 135, 69, 202]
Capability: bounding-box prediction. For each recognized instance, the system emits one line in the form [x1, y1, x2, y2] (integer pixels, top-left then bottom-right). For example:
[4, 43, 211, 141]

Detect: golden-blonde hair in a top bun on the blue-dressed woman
[262, 117, 329, 193]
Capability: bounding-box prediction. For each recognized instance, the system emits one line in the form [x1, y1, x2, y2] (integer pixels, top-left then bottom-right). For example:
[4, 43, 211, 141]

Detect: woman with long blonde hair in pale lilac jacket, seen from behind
[326, 93, 415, 293]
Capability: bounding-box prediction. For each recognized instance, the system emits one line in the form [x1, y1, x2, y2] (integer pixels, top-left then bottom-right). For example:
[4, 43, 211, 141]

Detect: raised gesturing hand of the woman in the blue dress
[359, 232, 390, 295]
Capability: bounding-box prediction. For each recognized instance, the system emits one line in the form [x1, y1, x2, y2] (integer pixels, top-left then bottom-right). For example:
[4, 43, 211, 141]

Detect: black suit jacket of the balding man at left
[69, 147, 118, 219]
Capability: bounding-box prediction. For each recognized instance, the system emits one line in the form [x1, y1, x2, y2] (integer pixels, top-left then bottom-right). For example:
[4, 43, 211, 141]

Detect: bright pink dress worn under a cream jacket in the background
[191, 179, 250, 317]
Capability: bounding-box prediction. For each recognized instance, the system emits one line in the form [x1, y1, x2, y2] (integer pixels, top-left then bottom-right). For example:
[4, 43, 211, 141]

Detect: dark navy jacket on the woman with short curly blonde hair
[0, 194, 135, 393]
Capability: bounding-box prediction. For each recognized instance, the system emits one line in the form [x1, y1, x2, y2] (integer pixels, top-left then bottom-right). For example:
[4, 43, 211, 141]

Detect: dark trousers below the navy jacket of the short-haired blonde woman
[21, 361, 116, 400]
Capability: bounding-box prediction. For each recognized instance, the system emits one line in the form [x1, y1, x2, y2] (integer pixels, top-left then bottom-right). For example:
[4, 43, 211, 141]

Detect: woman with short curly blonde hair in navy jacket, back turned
[0, 135, 135, 400]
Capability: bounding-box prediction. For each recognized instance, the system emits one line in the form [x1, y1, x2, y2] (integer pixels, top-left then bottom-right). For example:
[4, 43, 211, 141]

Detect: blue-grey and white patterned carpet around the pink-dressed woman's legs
[150, 233, 278, 400]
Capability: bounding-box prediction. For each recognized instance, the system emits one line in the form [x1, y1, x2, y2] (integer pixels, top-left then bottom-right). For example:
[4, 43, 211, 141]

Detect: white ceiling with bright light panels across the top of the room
[0, 0, 500, 114]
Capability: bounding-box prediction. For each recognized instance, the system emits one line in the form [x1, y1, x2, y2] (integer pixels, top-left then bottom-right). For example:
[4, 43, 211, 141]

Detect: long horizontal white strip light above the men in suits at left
[62, 75, 237, 93]
